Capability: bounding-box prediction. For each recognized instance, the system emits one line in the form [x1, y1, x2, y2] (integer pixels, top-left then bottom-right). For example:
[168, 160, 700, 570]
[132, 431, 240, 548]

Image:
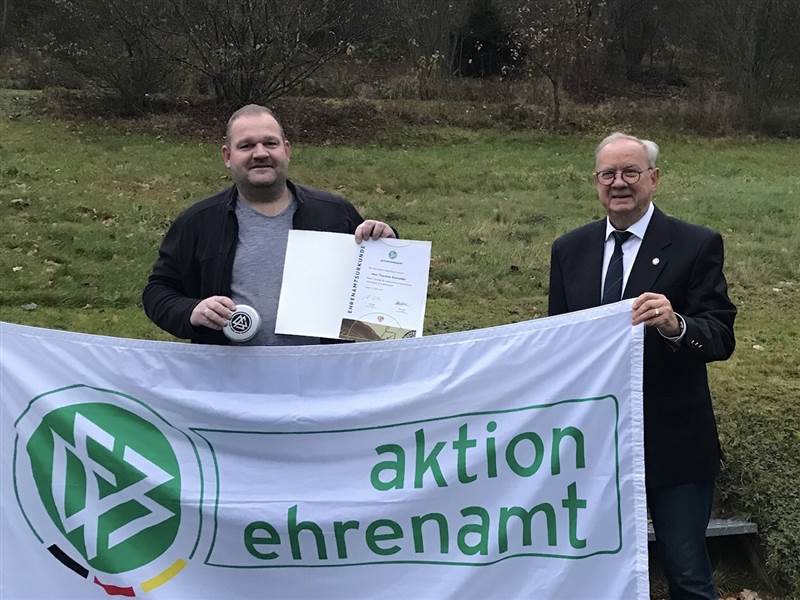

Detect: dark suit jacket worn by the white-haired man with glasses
[549, 208, 736, 488]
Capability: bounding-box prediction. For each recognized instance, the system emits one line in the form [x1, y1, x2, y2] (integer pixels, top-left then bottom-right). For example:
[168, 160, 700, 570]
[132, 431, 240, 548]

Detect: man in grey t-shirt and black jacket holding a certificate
[142, 104, 395, 345]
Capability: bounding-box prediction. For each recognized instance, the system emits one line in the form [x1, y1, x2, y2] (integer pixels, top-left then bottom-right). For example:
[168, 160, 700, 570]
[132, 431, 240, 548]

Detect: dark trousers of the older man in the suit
[647, 481, 718, 600]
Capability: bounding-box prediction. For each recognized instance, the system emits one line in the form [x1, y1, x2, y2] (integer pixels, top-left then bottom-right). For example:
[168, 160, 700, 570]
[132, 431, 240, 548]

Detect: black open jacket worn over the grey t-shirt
[142, 182, 364, 344]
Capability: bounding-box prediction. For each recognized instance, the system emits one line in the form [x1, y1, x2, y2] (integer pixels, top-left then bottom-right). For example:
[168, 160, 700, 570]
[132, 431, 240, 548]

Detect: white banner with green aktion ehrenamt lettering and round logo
[0, 301, 649, 600]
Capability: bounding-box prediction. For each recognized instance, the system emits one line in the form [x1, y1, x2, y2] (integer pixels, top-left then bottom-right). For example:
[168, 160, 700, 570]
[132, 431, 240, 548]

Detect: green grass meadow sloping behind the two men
[0, 105, 800, 593]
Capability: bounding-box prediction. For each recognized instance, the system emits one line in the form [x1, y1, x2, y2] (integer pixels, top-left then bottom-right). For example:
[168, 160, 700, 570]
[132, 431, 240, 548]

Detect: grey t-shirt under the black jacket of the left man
[231, 198, 320, 346]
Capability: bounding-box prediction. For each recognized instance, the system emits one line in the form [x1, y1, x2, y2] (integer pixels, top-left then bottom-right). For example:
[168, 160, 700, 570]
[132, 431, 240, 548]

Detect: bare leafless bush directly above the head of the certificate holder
[156, 0, 376, 104]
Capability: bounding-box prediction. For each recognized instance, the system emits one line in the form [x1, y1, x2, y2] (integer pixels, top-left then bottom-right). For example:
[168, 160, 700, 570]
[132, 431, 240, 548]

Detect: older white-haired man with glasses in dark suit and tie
[549, 133, 736, 600]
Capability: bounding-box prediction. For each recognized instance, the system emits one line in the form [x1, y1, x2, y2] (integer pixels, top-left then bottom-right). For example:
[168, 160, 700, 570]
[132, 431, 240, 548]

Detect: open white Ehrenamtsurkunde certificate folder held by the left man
[275, 230, 431, 340]
